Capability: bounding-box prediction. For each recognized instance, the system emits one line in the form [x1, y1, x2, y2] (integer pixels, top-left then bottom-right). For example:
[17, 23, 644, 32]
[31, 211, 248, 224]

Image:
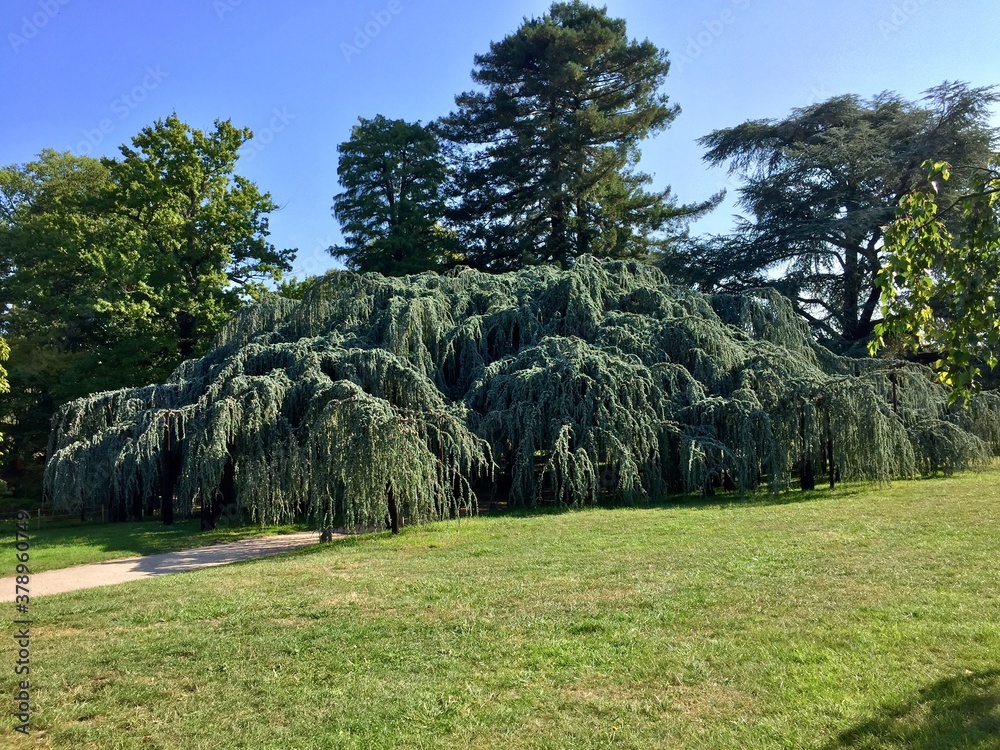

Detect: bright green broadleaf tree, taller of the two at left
[110, 115, 293, 367]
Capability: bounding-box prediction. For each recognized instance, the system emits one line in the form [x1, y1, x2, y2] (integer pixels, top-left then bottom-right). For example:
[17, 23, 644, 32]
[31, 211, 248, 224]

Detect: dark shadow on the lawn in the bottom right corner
[824, 669, 1000, 750]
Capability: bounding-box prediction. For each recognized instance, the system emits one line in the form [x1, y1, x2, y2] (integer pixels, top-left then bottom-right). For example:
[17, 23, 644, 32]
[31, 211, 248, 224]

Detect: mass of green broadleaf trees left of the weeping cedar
[0, 122, 291, 476]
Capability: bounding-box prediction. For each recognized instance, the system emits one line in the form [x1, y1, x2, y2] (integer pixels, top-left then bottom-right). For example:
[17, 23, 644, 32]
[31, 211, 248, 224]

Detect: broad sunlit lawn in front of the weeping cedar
[0, 471, 1000, 750]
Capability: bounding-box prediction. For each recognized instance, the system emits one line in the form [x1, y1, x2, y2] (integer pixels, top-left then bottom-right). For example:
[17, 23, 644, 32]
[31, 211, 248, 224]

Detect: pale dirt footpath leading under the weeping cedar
[0, 531, 328, 602]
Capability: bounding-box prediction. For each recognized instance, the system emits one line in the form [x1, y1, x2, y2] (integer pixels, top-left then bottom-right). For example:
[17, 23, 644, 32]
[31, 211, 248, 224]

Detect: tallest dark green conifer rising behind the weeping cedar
[440, 1, 708, 269]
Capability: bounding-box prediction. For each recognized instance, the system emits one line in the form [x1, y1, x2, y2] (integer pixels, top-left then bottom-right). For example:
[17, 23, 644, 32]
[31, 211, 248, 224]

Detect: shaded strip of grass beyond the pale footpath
[0, 519, 306, 577]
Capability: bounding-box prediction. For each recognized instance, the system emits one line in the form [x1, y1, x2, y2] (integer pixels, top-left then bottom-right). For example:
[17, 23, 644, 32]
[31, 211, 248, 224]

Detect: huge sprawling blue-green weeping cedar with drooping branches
[46, 256, 1000, 527]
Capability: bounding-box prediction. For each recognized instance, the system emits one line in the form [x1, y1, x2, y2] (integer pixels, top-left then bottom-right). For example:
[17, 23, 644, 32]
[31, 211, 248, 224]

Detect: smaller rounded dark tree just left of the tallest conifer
[330, 115, 456, 276]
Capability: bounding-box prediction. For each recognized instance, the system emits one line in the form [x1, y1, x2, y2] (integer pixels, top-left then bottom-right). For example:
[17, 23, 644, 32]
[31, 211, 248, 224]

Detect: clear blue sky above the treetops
[0, 0, 1000, 276]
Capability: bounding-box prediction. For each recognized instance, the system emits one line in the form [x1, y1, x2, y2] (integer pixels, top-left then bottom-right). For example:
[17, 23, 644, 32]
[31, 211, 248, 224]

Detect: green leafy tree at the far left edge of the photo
[0, 150, 127, 476]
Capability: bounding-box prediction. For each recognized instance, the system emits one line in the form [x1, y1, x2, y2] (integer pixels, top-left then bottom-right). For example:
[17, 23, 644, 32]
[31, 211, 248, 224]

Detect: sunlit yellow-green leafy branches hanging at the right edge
[870, 155, 1000, 402]
